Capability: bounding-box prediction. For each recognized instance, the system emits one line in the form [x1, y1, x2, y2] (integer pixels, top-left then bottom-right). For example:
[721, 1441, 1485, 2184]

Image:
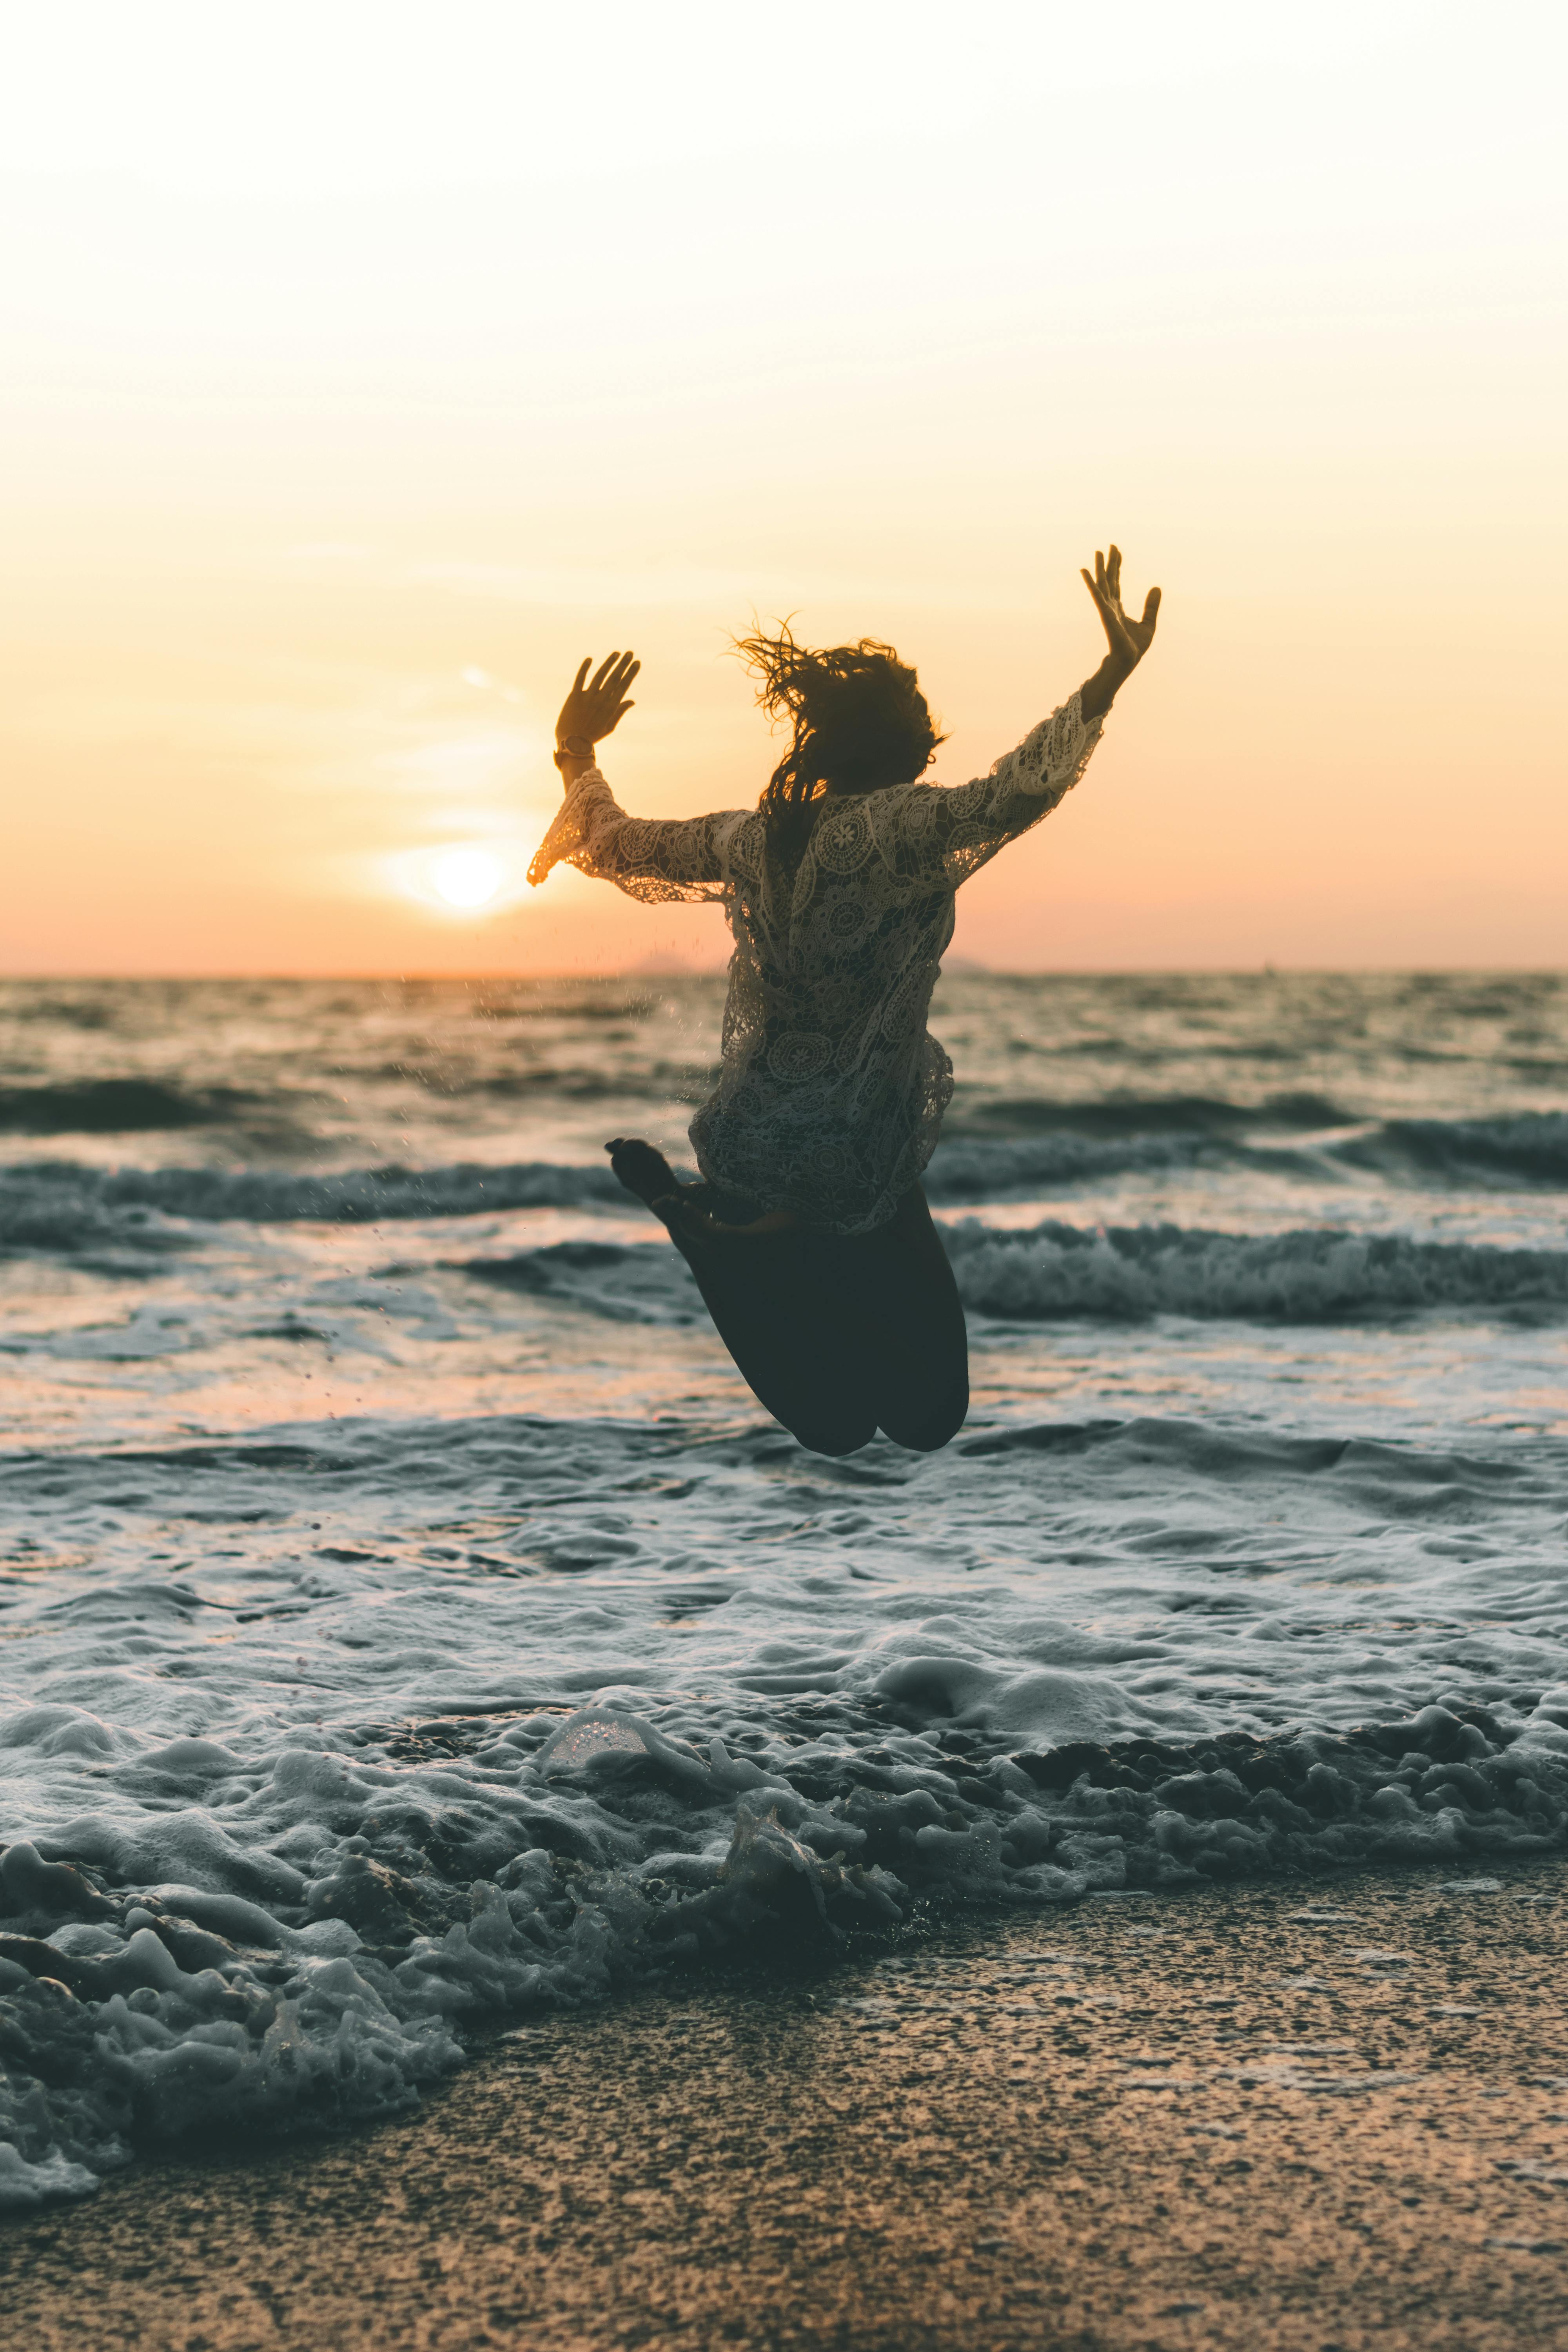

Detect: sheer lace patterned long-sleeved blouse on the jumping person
[529, 694, 1100, 1232]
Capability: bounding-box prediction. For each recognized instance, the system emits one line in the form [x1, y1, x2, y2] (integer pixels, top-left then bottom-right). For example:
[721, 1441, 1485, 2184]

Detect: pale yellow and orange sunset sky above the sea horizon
[0, 0, 1568, 974]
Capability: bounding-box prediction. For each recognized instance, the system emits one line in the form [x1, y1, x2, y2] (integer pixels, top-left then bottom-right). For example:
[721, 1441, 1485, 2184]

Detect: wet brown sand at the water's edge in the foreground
[0, 1863, 1568, 2352]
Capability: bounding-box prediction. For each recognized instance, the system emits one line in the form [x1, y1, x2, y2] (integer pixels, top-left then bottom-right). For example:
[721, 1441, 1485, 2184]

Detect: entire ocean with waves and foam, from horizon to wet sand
[0, 971, 1568, 2209]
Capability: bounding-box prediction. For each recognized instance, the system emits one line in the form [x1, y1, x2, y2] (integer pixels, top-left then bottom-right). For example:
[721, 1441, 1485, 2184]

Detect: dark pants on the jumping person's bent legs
[670, 1185, 969, 1454]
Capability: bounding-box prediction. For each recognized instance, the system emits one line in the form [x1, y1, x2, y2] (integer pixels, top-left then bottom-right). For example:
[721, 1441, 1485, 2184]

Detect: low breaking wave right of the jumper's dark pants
[945, 1218, 1568, 1322]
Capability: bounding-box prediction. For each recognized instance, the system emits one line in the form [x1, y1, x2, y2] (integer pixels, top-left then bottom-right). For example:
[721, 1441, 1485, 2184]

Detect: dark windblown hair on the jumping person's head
[733, 621, 947, 868]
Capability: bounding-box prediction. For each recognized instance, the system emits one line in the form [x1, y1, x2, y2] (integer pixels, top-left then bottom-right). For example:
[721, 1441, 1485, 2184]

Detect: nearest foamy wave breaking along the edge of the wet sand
[0, 1693, 1568, 2209]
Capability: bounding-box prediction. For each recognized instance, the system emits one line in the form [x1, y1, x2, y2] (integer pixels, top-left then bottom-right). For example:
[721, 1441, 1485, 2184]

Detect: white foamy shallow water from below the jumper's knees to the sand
[0, 1421, 1568, 2197]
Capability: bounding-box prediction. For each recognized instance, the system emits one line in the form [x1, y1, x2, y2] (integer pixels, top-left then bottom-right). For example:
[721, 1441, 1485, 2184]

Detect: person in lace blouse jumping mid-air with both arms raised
[529, 548, 1159, 1454]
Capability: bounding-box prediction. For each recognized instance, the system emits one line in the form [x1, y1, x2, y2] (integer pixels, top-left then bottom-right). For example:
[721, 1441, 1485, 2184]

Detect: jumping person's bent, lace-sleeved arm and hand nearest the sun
[529, 654, 736, 901]
